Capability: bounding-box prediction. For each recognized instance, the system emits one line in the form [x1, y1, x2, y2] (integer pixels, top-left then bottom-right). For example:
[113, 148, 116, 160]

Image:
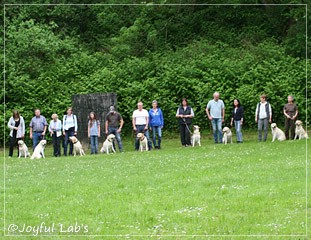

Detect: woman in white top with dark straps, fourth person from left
[63, 107, 78, 156]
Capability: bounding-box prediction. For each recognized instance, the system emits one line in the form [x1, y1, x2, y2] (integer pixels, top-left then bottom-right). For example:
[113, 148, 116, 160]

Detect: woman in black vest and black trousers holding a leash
[176, 98, 194, 147]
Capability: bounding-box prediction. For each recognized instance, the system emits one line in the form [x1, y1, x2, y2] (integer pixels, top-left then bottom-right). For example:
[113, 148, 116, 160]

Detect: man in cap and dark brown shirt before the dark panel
[105, 106, 124, 152]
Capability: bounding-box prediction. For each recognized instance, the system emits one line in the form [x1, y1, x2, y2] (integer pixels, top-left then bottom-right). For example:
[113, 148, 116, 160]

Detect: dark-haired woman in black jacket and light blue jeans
[231, 99, 244, 143]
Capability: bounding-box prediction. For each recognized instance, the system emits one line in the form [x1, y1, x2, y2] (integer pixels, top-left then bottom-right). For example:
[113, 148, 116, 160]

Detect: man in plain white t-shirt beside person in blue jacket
[132, 102, 152, 151]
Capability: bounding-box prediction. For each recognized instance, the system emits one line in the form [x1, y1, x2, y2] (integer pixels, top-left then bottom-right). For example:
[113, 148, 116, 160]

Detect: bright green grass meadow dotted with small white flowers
[1, 133, 310, 239]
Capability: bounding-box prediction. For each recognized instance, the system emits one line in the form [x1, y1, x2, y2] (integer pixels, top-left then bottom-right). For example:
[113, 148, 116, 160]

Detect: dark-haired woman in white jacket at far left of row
[8, 110, 25, 157]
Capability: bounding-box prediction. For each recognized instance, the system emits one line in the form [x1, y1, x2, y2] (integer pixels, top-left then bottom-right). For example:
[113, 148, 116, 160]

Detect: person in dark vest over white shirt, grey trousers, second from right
[255, 94, 272, 142]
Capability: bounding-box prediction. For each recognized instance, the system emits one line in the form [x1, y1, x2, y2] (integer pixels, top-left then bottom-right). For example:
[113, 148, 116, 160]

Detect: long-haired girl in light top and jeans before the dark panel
[87, 112, 100, 154]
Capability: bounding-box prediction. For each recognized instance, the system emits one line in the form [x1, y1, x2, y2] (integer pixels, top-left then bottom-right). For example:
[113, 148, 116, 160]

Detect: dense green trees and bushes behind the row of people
[0, 0, 311, 145]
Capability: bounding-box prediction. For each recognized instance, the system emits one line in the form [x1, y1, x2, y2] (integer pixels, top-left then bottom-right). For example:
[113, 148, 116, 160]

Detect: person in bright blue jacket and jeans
[149, 100, 164, 149]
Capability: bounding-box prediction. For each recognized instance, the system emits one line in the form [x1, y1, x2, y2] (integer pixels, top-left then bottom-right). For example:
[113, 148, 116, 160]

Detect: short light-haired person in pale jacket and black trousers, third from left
[49, 113, 62, 157]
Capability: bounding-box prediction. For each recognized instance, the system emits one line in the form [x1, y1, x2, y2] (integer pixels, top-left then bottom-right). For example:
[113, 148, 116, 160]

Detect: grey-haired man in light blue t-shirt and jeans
[206, 92, 225, 143]
